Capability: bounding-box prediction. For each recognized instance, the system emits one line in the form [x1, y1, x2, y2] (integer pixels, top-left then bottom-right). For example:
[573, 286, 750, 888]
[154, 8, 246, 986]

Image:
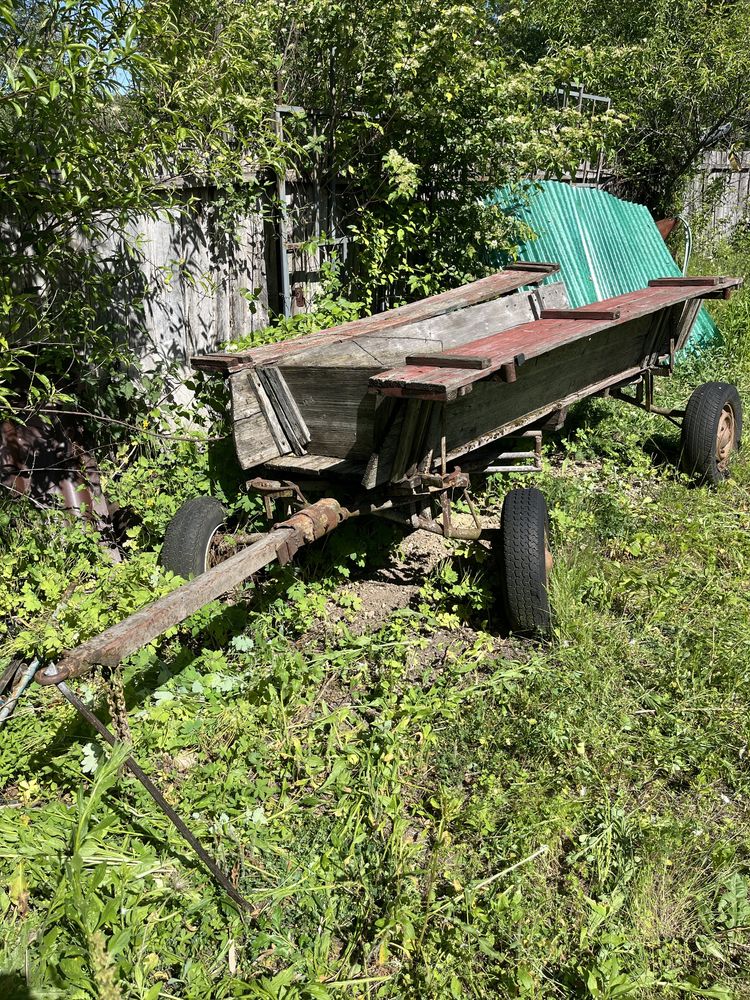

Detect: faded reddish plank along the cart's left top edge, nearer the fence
[190, 264, 559, 372]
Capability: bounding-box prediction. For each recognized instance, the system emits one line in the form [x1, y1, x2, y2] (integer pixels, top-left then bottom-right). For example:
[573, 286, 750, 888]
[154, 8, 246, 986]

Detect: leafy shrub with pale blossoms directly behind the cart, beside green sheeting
[268, 0, 619, 307]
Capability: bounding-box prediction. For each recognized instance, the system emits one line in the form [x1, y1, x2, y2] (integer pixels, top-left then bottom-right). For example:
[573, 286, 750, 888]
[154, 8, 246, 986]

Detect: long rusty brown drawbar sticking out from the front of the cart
[35, 499, 350, 684]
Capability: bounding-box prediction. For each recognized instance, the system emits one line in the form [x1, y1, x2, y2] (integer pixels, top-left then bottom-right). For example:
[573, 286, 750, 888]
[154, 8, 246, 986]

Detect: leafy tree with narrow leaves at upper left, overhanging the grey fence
[0, 0, 284, 418]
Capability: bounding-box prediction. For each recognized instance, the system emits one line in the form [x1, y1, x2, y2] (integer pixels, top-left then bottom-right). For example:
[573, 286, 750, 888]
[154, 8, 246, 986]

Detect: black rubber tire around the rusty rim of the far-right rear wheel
[681, 382, 742, 486]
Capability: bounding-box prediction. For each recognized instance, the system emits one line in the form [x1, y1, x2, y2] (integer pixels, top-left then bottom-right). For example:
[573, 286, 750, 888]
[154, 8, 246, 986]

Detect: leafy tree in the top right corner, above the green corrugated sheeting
[517, 0, 750, 214]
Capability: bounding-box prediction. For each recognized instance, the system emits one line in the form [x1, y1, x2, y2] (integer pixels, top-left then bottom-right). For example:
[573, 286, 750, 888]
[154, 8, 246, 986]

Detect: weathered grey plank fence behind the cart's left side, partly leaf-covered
[97, 176, 345, 366]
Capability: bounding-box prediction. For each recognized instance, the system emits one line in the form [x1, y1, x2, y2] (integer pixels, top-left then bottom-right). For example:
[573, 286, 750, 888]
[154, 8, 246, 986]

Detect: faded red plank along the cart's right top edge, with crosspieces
[370, 278, 742, 399]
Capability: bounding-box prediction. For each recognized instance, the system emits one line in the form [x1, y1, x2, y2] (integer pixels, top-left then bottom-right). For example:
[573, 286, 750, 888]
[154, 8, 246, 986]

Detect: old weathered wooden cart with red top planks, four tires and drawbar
[26, 264, 742, 684]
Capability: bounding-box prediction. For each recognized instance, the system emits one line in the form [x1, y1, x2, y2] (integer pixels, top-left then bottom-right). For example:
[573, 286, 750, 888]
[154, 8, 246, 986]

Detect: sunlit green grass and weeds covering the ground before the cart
[0, 248, 750, 1000]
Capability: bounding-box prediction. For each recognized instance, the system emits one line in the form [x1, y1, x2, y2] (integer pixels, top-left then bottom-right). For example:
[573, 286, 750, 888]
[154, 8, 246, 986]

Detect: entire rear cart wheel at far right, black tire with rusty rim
[682, 382, 742, 485]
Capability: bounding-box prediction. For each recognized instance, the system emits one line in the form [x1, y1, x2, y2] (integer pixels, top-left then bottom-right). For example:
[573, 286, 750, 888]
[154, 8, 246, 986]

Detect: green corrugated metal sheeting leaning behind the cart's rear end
[493, 181, 718, 347]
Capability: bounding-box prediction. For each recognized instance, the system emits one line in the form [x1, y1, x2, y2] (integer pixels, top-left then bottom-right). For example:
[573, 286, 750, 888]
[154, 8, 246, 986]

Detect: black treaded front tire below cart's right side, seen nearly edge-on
[497, 487, 552, 638]
